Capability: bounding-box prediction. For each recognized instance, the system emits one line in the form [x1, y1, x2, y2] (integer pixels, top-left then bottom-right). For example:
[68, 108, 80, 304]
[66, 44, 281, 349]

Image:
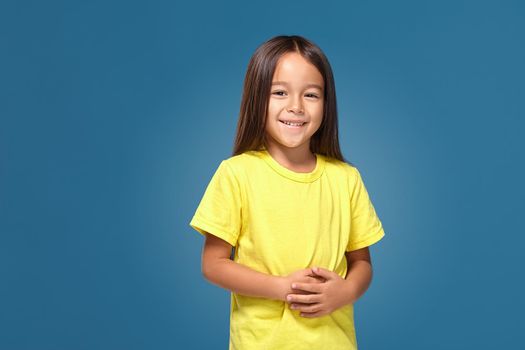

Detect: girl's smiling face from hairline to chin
[265, 52, 324, 154]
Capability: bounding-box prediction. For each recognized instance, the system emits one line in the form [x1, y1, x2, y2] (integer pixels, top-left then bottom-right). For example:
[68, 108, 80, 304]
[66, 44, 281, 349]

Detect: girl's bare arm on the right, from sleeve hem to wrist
[345, 247, 372, 304]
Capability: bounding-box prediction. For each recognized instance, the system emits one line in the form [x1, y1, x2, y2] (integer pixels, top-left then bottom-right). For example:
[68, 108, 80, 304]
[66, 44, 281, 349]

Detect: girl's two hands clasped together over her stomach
[282, 267, 354, 318]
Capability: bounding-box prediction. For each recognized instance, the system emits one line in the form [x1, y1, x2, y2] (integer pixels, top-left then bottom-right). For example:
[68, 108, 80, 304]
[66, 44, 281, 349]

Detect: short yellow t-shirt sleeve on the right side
[346, 168, 385, 252]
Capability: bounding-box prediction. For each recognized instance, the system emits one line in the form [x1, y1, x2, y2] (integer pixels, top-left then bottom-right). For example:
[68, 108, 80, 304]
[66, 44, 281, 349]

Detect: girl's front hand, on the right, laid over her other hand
[286, 267, 354, 317]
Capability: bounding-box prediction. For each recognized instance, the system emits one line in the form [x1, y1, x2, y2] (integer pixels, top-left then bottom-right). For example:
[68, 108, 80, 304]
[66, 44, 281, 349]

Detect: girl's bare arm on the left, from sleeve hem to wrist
[202, 233, 285, 300]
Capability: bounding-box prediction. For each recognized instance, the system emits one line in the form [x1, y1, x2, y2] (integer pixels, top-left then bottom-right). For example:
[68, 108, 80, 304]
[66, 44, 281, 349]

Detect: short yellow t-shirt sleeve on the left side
[189, 160, 242, 247]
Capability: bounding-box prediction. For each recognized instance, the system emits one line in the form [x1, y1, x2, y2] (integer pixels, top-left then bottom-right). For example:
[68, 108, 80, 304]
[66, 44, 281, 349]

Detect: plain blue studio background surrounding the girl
[0, 1, 525, 349]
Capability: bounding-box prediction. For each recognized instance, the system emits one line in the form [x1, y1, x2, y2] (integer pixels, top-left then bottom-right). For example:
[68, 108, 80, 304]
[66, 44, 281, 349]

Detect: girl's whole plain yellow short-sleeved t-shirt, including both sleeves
[190, 149, 384, 350]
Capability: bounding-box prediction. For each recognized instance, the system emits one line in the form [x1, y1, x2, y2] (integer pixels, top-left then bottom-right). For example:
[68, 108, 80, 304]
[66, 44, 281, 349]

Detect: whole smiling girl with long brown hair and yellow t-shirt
[190, 36, 384, 350]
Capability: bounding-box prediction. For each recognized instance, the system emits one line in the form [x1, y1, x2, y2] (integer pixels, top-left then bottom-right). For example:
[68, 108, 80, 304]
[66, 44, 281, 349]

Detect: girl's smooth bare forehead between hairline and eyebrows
[272, 52, 324, 87]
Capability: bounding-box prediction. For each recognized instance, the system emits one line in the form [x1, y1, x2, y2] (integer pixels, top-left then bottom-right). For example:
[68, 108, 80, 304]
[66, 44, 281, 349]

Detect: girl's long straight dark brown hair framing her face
[232, 35, 351, 164]
